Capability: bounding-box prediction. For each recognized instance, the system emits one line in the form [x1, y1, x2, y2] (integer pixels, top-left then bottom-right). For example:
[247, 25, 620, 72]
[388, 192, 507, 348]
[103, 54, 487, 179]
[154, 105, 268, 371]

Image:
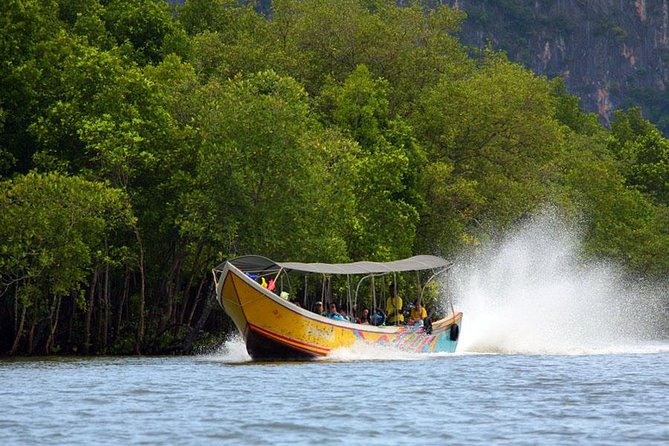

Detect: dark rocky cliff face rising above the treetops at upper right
[444, 0, 669, 134]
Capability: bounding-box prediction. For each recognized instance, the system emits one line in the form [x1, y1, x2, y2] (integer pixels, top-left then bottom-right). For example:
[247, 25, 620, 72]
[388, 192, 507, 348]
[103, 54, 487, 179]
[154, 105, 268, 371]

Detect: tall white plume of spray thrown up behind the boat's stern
[447, 211, 669, 354]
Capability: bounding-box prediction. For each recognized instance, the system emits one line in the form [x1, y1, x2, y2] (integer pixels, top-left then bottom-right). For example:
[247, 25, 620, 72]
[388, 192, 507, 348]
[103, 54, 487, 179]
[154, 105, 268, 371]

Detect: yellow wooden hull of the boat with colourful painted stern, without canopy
[217, 263, 462, 360]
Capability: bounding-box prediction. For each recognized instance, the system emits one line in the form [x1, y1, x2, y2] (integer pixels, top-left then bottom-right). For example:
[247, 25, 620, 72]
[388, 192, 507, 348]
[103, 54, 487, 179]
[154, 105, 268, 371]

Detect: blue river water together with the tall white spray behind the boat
[0, 214, 669, 445]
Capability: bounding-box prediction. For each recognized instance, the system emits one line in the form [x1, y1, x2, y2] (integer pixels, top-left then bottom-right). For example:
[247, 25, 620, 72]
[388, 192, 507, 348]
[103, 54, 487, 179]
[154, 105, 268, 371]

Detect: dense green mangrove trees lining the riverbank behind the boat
[0, 0, 669, 354]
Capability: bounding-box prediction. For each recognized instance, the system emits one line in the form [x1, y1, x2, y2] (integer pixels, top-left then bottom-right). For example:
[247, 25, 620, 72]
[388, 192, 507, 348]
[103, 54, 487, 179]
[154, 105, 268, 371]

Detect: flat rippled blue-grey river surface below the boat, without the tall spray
[0, 345, 669, 444]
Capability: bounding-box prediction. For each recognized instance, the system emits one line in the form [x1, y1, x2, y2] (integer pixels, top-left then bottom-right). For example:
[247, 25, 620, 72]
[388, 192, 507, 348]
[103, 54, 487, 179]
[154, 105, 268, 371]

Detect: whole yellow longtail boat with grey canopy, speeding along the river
[213, 255, 462, 360]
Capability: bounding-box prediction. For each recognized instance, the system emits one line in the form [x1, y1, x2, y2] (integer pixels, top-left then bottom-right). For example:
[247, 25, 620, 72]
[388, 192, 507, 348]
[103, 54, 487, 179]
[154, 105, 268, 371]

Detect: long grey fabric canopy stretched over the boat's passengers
[215, 255, 451, 274]
